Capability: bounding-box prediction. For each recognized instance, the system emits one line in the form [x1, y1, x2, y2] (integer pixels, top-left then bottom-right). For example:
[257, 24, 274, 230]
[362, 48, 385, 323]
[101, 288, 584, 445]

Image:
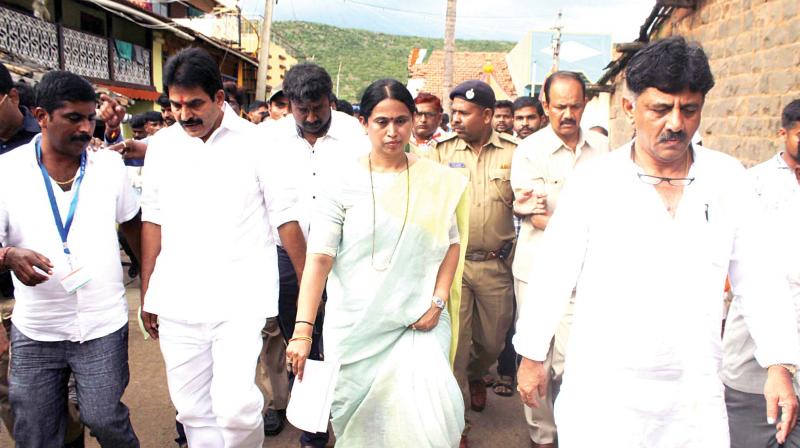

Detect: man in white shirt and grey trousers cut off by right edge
[720, 100, 800, 448]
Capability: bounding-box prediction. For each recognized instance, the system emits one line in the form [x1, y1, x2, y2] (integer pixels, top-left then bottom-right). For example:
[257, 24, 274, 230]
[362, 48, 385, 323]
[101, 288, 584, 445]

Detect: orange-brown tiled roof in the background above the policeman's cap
[408, 50, 517, 98]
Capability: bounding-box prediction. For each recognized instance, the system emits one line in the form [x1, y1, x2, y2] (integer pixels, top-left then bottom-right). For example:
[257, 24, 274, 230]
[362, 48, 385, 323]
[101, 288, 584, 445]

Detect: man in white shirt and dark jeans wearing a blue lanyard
[0, 71, 141, 448]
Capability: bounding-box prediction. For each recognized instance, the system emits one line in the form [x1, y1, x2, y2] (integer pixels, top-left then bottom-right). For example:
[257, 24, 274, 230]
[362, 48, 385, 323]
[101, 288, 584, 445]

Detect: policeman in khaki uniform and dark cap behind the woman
[427, 81, 517, 447]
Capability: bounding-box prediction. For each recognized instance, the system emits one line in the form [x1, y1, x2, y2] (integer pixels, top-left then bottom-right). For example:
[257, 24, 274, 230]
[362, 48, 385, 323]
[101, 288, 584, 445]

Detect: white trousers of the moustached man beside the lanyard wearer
[159, 318, 265, 448]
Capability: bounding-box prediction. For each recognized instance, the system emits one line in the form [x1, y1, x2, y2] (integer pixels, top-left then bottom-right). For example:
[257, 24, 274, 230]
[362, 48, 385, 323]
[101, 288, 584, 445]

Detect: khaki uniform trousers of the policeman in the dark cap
[453, 259, 514, 434]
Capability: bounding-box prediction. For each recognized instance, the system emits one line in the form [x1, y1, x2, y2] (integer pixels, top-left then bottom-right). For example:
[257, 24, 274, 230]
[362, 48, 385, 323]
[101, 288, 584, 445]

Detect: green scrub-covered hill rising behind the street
[272, 21, 515, 102]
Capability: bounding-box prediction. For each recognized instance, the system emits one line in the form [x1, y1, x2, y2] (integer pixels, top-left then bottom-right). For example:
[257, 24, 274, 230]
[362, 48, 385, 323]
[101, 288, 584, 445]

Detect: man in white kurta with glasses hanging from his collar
[514, 36, 800, 448]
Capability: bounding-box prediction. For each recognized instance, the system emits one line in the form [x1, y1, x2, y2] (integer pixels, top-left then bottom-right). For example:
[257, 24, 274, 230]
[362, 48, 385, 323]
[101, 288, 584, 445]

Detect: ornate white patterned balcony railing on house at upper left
[0, 6, 152, 87]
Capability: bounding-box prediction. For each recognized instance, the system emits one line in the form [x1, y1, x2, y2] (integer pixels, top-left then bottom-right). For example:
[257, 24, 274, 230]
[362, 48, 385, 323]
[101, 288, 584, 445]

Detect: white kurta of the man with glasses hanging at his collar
[514, 144, 800, 448]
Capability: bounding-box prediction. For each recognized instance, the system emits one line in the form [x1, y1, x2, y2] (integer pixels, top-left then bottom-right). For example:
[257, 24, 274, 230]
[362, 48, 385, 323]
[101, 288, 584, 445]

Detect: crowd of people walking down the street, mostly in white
[0, 37, 800, 448]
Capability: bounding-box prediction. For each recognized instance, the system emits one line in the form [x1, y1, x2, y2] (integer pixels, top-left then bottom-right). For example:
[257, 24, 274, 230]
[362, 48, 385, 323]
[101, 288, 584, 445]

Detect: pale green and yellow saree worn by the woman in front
[309, 159, 469, 448]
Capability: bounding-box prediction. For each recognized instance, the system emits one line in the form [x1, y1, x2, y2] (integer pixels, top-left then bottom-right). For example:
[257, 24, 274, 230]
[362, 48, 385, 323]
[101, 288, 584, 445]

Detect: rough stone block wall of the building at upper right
[609, 0, 800, 166]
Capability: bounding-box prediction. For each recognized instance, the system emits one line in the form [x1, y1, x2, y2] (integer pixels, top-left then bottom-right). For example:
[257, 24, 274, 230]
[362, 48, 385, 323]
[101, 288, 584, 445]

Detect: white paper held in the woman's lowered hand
[286, 359, 340, 432]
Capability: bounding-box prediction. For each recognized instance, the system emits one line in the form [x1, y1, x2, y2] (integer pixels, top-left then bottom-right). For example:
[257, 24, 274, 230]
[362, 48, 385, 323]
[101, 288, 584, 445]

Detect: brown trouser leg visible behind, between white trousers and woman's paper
[256, 317, 289, 413]
